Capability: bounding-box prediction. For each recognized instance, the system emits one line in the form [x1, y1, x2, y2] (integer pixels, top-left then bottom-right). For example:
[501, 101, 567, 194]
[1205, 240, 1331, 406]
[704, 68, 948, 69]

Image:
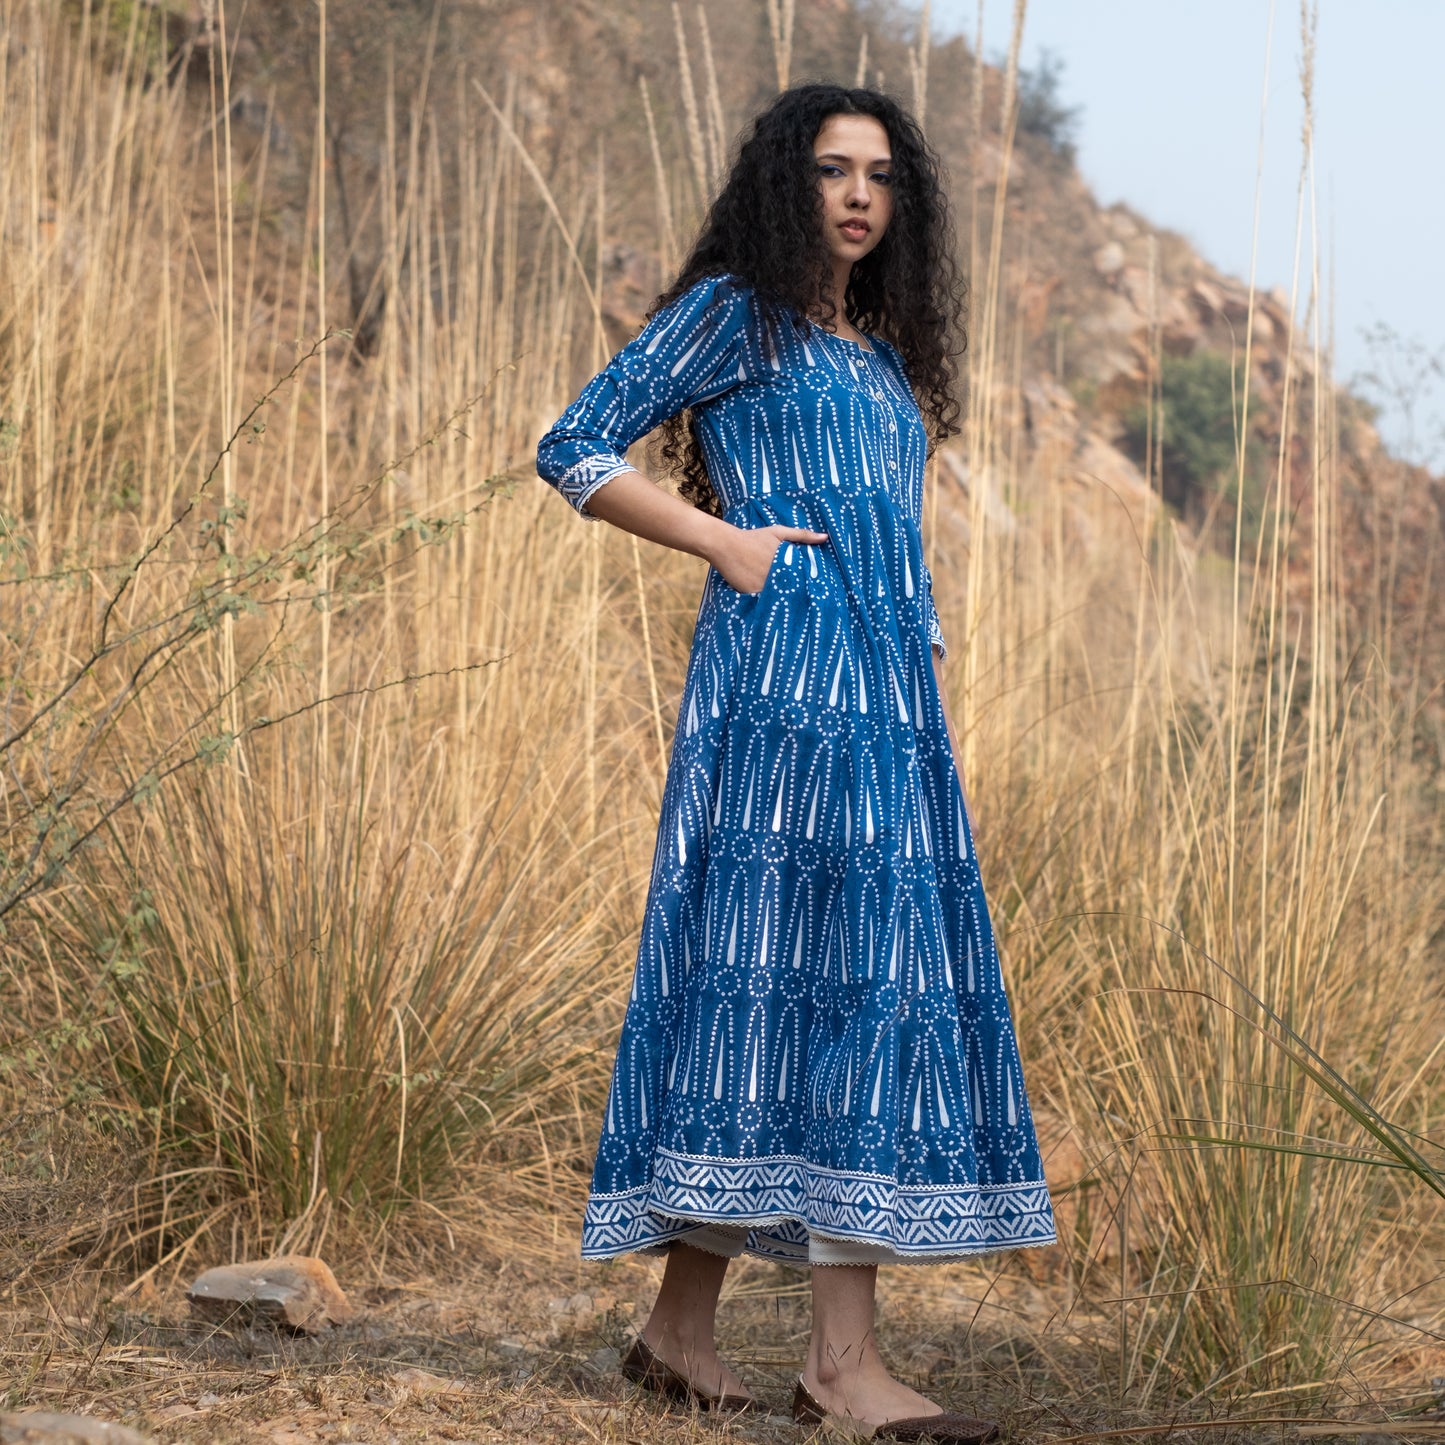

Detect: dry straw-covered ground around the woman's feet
[0, 1242, 1445, 1445]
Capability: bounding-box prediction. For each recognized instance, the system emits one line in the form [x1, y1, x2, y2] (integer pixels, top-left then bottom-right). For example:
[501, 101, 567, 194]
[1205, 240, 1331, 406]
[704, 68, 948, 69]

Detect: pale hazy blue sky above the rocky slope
[933, 0, 1445, 468]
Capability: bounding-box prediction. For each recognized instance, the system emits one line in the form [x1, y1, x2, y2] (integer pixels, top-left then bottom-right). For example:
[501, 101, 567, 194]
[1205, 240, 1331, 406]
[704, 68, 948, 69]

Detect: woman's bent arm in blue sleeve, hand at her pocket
[538, 277, 828, 592]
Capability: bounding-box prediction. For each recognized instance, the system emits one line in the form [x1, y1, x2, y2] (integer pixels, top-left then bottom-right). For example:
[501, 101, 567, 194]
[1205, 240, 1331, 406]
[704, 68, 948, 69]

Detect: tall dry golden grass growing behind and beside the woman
[0, 0, 1445, 1400]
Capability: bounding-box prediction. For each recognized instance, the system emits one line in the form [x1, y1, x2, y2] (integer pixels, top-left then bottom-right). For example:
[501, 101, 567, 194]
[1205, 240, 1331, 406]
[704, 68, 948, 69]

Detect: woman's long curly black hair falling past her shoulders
[649, 84, 967, 514]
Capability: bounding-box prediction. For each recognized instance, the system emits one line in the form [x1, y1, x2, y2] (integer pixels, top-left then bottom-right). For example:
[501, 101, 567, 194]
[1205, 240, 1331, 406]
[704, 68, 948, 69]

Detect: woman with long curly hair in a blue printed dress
[538, 85, 1055, 1441]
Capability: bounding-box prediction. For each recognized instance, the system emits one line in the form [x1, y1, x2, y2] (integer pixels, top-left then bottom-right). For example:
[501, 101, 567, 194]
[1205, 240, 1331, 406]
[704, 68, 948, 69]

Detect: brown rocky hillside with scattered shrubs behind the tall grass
[143, 0, 1445, 676]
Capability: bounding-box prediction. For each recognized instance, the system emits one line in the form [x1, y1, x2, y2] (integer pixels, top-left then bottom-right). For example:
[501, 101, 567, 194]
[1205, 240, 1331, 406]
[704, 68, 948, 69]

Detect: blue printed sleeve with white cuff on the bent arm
[536, 276, 751, 519]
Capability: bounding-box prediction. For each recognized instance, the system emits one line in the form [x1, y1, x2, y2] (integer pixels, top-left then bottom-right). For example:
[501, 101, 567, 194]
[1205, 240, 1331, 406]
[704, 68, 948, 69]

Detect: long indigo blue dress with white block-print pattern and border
[538, 277, 1055, 1261]
